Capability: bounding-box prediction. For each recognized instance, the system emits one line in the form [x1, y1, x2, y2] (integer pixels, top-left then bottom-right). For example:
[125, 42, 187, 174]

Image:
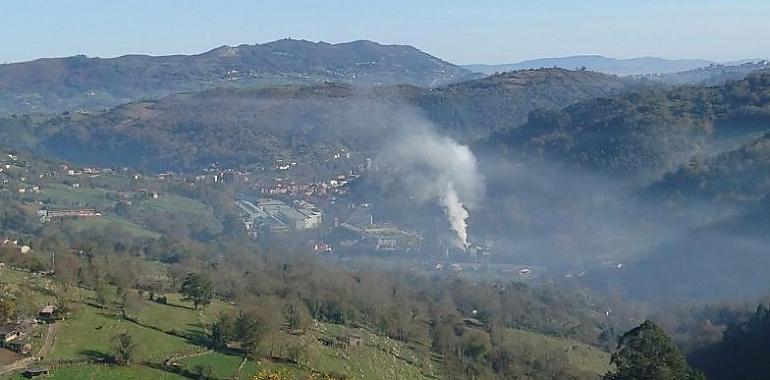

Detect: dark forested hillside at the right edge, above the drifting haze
[490, 74, 770, 178]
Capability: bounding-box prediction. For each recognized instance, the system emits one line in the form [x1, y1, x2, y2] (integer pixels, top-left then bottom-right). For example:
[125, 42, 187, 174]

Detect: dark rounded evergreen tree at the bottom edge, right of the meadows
[604, 320, 705, 380]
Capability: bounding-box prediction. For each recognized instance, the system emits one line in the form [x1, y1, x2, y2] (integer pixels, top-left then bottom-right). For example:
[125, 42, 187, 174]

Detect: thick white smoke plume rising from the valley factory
[381, 118, 484, 250]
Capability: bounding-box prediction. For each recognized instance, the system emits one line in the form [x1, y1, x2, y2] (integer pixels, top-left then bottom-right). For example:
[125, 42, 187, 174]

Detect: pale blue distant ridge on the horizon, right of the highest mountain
[463, 55, 715, 76]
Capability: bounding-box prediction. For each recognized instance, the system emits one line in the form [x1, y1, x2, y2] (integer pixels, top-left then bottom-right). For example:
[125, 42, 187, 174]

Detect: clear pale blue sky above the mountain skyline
[0, 0, 770, 64]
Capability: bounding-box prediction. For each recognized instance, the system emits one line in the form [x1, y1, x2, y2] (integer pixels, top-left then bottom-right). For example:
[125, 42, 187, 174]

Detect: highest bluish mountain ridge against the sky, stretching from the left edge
[0, 39, 473, 113]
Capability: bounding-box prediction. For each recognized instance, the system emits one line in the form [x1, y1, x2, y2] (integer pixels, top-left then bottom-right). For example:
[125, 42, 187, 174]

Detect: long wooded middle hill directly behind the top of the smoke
[0, 69, 635, 170]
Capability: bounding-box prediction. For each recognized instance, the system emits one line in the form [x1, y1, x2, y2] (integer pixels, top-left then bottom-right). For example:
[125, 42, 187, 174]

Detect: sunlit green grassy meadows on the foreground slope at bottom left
[0, 267, 609, 380]
